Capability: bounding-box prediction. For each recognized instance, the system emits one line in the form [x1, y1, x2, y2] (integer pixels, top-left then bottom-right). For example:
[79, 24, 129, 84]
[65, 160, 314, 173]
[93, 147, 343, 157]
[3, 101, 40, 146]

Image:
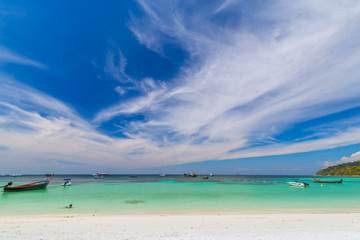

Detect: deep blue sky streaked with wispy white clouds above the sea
[0, 0, 360, 175]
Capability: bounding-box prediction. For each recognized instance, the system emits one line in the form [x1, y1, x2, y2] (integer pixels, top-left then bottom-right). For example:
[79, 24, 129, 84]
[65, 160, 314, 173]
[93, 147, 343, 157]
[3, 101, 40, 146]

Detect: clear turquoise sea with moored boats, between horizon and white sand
[0, 175, 360, 216]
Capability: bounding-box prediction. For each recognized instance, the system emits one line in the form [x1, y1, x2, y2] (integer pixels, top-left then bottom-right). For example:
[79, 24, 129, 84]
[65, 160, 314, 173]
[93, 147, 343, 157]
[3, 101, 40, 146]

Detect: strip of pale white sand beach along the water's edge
[0, 213, 360, 240]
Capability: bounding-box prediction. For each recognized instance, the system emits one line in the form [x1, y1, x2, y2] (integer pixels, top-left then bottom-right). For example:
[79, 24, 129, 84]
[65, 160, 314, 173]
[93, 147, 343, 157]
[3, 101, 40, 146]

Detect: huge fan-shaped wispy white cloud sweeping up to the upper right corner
[95, 0, 360, 162]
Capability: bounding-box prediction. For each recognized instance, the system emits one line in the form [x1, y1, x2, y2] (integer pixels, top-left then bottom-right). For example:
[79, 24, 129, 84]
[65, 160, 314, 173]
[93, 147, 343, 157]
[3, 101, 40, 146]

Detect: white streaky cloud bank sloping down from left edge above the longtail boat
[0, 76, 166, 172]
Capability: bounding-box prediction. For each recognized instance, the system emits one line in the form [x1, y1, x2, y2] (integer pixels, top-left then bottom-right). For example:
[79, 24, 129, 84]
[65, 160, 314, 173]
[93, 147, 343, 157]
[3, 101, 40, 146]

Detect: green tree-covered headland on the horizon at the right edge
[316, 161, 360, 176]
